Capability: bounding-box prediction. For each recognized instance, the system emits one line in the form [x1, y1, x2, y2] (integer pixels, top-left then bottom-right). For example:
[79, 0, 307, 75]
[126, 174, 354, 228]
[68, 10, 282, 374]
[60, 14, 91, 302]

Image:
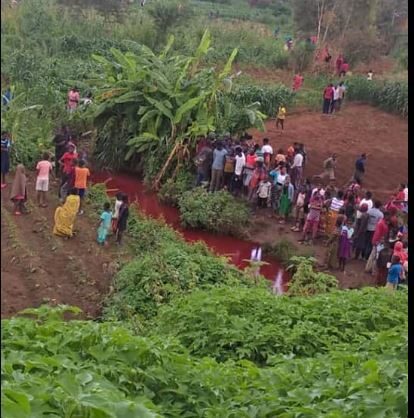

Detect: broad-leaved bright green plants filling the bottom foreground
[1, 304, 408, 418]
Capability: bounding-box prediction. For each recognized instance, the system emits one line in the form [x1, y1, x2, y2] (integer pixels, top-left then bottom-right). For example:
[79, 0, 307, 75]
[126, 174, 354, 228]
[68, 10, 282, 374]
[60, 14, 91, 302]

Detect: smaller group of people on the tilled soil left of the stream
[1, 127, 129, 245]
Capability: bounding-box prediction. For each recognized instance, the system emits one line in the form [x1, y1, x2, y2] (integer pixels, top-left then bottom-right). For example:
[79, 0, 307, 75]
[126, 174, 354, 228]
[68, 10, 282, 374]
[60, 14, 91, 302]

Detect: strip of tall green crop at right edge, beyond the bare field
[347, 77, 408, 118]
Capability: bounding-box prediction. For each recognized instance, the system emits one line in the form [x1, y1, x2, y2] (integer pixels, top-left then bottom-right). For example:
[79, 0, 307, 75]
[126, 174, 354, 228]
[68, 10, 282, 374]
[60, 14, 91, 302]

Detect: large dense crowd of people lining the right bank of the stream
[195, 135, 408, 290]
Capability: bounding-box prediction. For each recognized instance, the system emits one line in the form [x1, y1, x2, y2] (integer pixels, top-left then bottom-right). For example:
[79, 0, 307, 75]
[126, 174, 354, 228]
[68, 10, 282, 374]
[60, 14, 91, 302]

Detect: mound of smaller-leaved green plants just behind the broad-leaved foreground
[152, 287, 407, 365]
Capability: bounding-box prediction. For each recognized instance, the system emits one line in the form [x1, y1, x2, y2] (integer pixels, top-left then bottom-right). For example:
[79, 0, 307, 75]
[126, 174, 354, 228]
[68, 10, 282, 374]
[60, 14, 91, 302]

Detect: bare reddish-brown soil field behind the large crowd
[252, 103, 408, 200]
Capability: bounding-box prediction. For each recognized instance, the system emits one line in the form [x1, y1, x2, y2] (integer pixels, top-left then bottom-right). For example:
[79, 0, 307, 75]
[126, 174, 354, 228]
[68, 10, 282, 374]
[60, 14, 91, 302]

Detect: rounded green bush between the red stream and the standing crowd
[178, 187, 250, 235]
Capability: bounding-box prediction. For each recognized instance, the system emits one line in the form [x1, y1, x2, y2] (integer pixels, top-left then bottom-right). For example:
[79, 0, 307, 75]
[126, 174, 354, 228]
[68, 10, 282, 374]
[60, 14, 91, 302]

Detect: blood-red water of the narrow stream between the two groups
[93, 172, 287, 283]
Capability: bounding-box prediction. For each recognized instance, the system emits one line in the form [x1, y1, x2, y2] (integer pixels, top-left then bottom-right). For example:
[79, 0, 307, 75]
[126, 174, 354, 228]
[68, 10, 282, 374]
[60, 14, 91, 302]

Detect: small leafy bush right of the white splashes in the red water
[287, 256, 338, 296]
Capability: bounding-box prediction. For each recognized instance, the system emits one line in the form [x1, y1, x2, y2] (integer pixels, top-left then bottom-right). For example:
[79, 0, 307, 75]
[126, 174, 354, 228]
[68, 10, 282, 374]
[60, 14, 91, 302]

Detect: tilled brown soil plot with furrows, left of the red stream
[1, 175, 128, 318]
